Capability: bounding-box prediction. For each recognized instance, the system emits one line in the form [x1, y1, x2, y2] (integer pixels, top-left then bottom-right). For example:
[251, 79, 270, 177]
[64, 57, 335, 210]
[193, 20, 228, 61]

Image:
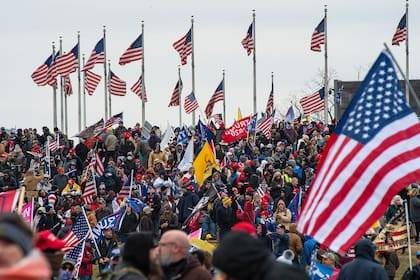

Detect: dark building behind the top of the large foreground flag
[330, 80, 420, 120]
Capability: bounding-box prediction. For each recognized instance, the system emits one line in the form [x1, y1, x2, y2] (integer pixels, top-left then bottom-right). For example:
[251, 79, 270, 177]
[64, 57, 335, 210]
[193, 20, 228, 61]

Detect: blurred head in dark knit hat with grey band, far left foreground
[0, 213, 33, 268]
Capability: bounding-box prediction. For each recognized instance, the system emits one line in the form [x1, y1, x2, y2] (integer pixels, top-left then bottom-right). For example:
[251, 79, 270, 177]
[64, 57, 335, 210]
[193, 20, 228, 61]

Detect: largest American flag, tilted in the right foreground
[298, 51, 420, 253]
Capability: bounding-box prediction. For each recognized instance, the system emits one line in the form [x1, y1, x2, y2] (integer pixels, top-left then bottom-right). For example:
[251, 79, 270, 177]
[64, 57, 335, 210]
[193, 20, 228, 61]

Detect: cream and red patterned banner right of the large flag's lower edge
[373, 208, 408, 252]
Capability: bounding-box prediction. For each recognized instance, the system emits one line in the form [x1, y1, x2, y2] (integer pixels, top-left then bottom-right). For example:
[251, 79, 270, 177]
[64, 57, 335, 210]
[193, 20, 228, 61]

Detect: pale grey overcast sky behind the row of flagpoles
[0, 0, 420, 135]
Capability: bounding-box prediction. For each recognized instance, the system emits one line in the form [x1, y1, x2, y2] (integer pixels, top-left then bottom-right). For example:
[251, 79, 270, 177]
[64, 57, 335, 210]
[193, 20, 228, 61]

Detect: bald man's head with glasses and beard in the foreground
[159, 230, 190, 266]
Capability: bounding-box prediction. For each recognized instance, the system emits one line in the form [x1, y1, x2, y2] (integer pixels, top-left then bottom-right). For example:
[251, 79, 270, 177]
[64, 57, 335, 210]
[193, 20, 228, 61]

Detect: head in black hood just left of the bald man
[122, 232, 157, 275]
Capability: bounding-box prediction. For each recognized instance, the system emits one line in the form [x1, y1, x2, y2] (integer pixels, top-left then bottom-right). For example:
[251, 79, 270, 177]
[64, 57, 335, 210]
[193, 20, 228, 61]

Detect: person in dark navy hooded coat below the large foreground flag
[337, 239, 388, 280]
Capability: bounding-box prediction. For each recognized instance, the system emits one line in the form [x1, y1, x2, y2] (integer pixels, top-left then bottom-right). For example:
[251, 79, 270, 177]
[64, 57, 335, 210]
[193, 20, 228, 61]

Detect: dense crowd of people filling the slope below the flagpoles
[0, 119, 420, 279]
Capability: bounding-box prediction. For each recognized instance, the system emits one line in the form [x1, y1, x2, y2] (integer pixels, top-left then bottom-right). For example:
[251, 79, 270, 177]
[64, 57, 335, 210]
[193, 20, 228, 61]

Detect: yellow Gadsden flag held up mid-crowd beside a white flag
[193, 141, 220, 187]
